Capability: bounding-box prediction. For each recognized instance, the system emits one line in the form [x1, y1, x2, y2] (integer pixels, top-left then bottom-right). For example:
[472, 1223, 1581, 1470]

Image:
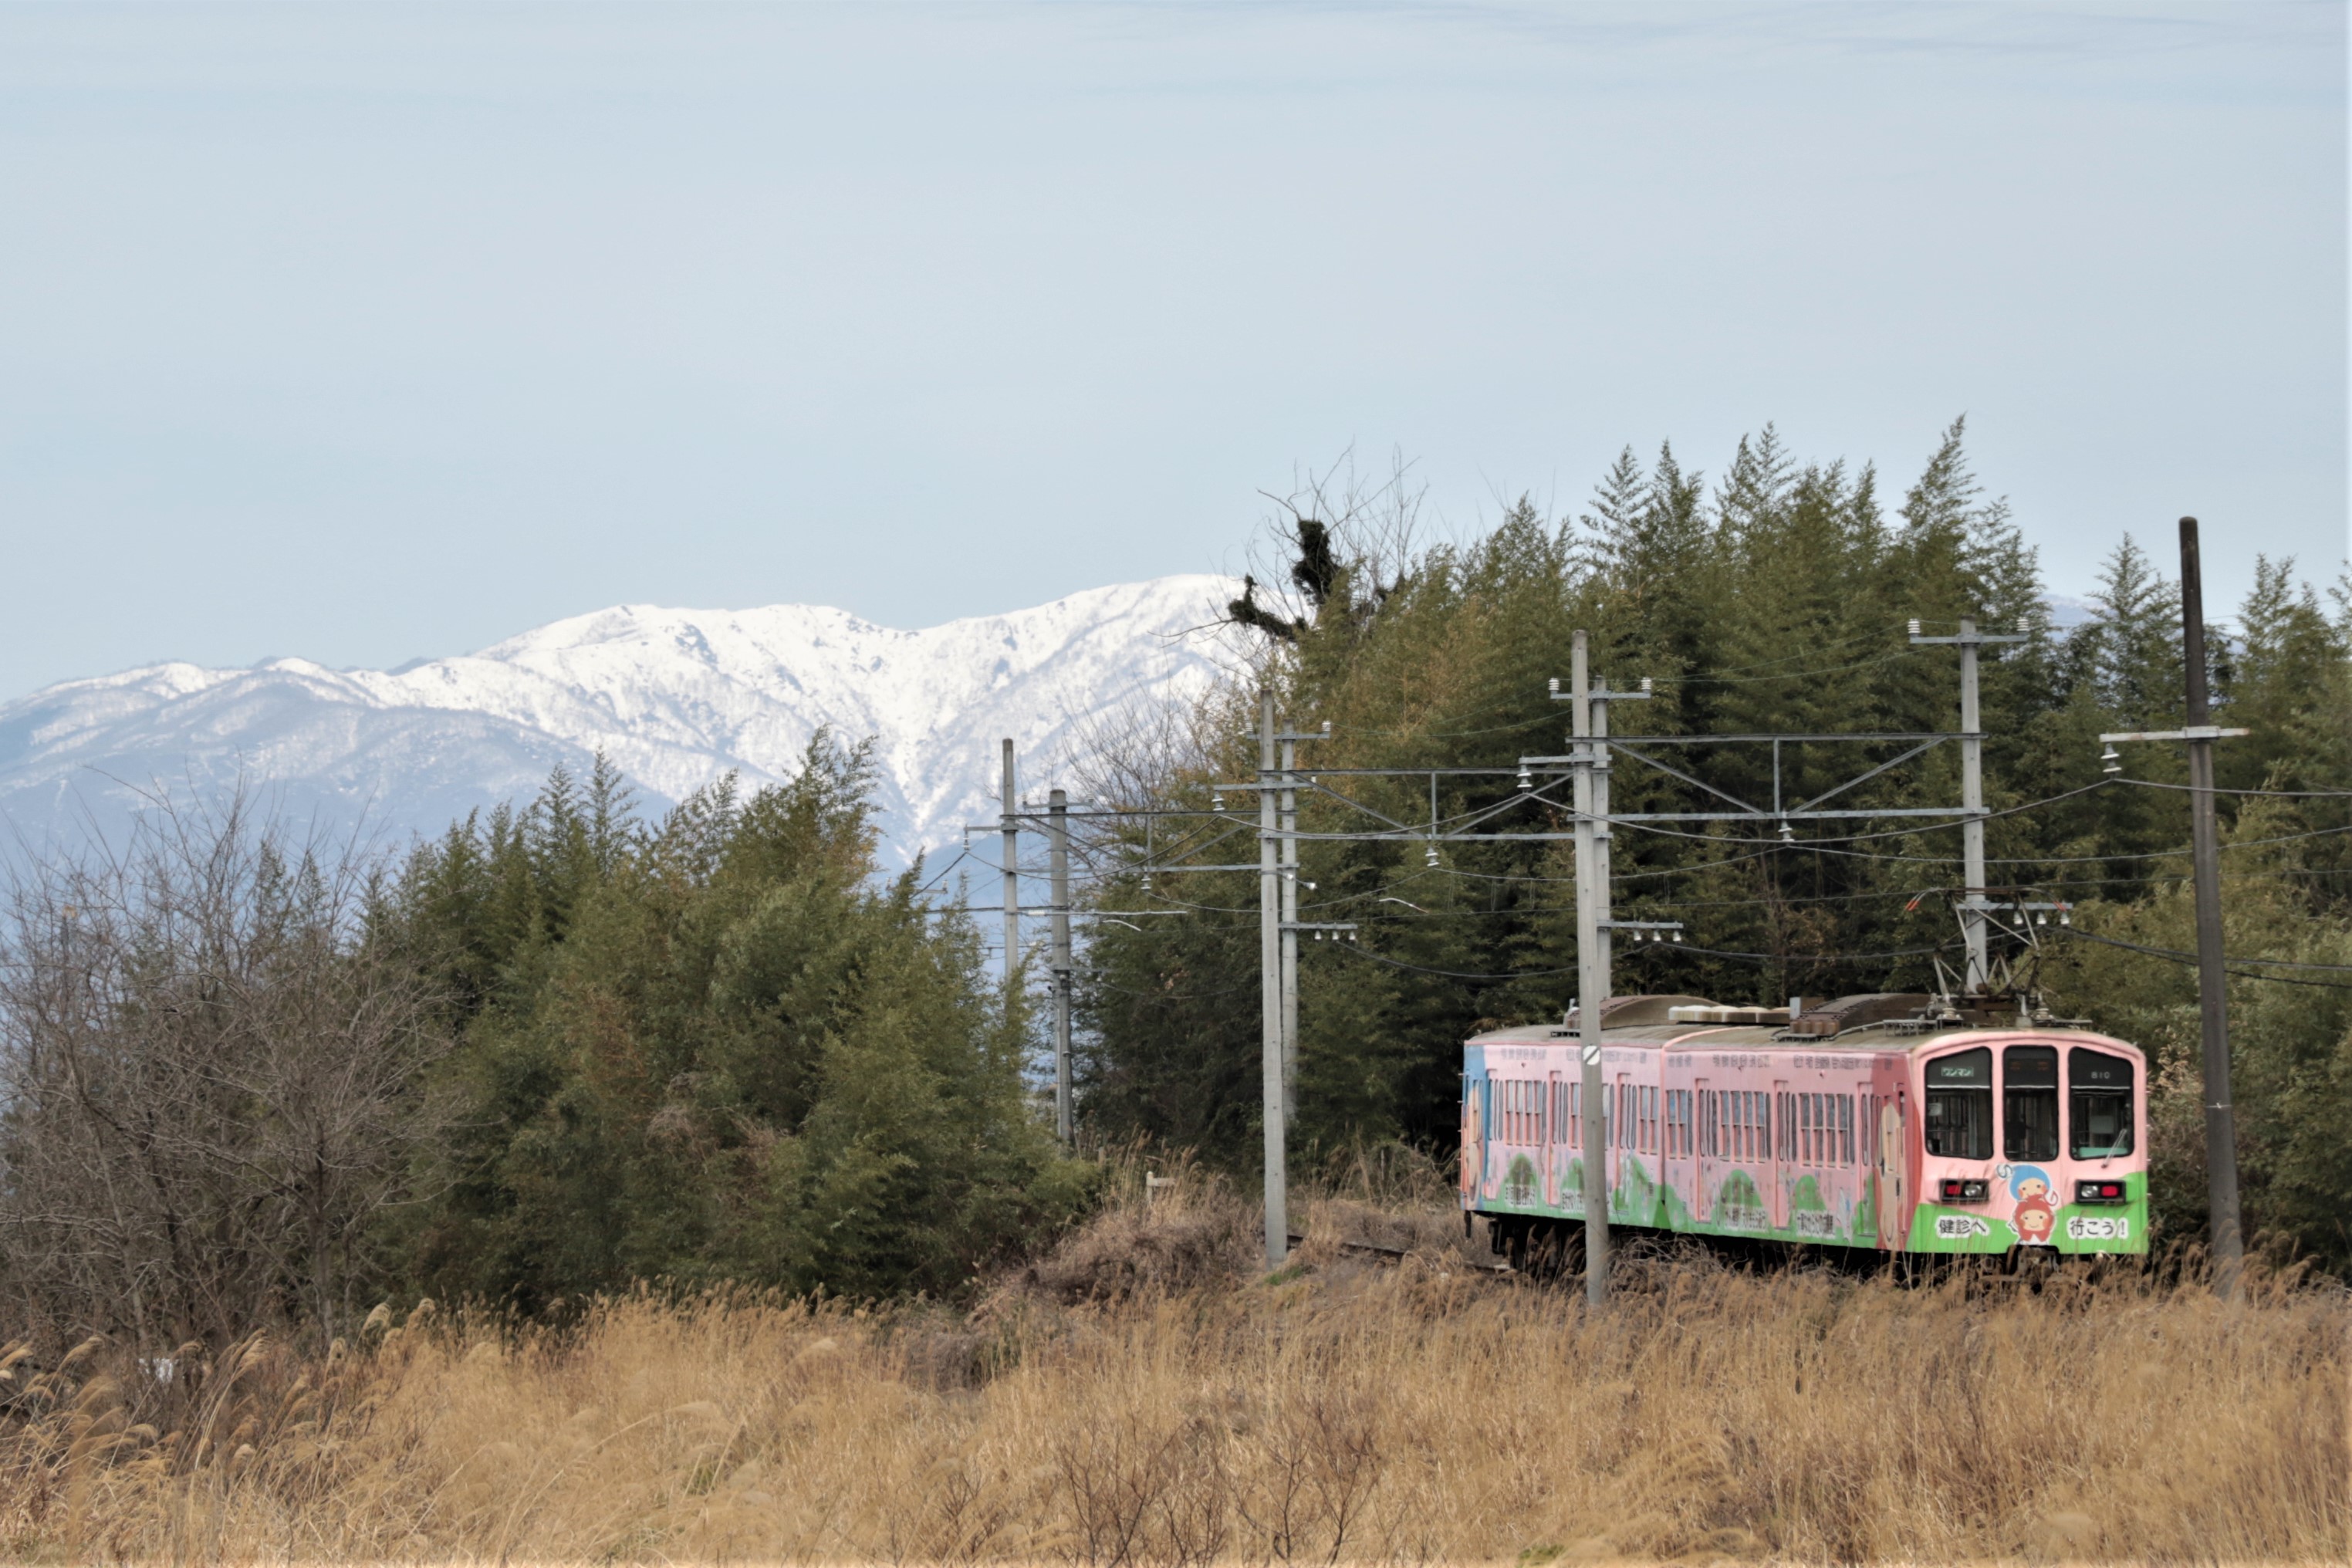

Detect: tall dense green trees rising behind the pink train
[1080, 423, 2352, 1269]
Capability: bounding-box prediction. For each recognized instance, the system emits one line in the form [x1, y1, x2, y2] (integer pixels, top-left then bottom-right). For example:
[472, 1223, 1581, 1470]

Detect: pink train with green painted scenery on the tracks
[1461, 997, 2148, 1255]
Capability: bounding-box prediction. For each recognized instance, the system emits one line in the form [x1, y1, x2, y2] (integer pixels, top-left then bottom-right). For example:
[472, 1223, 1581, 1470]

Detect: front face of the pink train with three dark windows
[1905, 1029, 2148, 1253]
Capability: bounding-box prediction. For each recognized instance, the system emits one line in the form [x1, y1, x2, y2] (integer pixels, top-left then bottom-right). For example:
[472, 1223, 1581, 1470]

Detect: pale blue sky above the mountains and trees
[0, 0, 2345, 696]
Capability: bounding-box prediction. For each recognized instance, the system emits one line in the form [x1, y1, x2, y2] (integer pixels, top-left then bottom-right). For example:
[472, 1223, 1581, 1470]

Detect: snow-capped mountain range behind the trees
[0, 576, 1235, 863]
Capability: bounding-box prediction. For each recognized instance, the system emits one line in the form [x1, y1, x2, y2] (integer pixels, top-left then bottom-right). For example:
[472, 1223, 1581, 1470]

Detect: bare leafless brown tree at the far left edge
[0, 797, 449, 1352]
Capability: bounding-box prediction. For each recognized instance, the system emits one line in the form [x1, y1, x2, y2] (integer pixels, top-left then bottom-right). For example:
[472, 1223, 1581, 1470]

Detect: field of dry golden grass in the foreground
[0, 1190, 2352, 1566]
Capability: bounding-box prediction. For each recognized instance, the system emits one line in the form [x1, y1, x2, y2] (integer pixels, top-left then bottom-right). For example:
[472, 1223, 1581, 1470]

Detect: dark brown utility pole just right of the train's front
[2180, 517, 2246, 1300]
